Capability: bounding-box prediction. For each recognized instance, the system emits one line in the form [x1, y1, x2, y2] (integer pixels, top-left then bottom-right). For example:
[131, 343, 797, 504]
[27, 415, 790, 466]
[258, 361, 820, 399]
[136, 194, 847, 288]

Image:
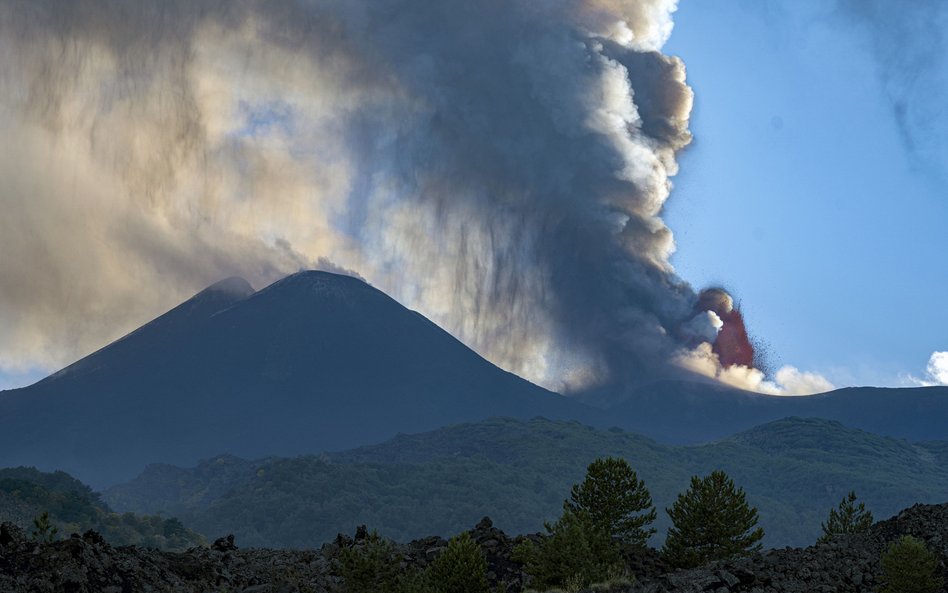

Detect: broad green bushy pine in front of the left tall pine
[514, 507, 625, 589]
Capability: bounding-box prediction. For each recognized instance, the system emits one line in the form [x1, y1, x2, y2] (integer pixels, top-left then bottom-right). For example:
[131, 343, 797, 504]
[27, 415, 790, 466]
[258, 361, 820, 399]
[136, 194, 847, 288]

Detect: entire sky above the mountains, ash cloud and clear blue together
[0, 0, 948, 393]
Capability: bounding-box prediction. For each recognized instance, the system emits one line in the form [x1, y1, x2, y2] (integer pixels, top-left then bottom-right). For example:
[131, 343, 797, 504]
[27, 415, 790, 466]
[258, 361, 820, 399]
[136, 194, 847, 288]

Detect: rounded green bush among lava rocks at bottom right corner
[881, 535, 943, 593]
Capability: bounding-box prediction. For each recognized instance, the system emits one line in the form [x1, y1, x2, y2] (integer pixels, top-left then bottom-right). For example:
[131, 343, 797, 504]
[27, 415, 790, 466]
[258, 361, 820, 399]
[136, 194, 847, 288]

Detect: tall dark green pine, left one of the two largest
[565, 457, 655, 547]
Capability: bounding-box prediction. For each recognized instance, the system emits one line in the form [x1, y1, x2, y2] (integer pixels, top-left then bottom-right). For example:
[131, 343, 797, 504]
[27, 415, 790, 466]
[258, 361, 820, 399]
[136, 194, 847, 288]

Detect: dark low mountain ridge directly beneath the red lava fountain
[609, 381, 948, 443]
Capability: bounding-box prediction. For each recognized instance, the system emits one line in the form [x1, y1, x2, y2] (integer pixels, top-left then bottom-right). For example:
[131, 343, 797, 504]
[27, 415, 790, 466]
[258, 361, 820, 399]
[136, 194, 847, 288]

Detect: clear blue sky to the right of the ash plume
[666, 0, 948, 385]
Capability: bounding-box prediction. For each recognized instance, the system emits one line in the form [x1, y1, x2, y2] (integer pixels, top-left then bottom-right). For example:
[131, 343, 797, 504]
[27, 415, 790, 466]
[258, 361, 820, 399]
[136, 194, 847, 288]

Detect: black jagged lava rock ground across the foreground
[0, 504, 948, 593]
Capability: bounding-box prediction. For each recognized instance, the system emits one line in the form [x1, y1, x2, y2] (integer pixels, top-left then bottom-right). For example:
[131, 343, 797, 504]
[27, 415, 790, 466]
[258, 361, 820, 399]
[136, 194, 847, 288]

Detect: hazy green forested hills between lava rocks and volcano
[105, 418, 948, 547]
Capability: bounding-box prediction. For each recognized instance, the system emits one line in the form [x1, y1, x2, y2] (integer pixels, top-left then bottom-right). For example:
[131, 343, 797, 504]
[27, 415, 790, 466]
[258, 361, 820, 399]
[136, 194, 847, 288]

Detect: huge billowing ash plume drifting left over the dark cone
[0, 0, 824, 398]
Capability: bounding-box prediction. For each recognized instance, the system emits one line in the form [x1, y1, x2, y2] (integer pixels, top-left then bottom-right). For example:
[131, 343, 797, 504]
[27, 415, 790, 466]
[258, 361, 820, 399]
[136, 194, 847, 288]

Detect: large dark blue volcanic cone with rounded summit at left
[0, 272, 594, 486]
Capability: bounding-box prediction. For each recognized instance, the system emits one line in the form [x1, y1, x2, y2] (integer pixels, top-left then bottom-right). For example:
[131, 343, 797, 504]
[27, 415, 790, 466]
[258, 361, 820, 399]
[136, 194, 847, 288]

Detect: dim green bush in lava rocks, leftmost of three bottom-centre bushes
[338, 531, 402, 593]
